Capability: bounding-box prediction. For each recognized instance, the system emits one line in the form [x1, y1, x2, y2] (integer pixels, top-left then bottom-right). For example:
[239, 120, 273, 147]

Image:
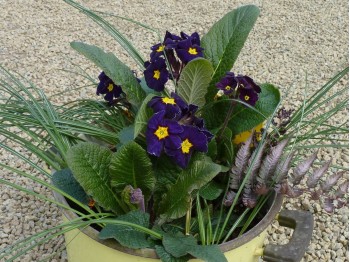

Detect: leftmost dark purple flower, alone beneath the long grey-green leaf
[96, 72, 123, 104]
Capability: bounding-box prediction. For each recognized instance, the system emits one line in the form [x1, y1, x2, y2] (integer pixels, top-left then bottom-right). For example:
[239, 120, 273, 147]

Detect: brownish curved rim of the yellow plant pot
[53, 192, 283, 259]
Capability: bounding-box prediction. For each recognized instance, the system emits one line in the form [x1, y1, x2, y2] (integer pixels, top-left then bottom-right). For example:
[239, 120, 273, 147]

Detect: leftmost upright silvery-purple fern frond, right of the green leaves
[230, 132, 255, 189]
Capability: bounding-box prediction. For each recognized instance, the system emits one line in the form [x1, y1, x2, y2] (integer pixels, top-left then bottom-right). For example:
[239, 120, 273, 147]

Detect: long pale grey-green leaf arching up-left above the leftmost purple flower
[70, 42, 146, 105]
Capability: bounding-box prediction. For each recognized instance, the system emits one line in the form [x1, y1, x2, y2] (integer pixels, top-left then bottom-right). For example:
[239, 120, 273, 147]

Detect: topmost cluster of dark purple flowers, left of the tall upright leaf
[144, 31, 203, 91]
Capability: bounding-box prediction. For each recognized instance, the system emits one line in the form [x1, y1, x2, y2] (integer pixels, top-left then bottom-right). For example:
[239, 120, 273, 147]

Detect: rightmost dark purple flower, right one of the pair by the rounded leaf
[236, 75, 261, 106]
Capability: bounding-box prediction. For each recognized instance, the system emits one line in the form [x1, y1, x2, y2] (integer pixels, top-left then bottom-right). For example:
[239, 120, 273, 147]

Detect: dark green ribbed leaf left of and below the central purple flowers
[109, 142, 155, 200]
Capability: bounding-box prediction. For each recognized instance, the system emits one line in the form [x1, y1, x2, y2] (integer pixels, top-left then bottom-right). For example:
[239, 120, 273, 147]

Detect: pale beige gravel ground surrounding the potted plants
[0, 0, 349, 262]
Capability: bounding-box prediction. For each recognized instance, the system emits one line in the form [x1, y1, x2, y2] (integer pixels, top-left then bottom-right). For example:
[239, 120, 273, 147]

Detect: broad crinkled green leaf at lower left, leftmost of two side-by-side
[67, 143, 125, 214]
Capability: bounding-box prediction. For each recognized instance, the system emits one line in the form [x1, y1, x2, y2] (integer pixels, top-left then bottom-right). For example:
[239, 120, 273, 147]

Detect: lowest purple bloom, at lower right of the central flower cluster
[165, 126, 208, 168]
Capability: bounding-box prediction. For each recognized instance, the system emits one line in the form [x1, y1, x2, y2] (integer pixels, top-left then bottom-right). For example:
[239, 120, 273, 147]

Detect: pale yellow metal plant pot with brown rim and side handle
[54, 190, 313, 262]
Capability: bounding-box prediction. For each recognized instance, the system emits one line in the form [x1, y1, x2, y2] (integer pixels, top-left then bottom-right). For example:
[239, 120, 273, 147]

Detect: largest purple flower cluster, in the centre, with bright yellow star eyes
[146, 93, 213, 168]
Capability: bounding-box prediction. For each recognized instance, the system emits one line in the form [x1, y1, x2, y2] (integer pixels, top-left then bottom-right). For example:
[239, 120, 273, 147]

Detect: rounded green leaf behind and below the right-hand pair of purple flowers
[228, 84, 280, 136]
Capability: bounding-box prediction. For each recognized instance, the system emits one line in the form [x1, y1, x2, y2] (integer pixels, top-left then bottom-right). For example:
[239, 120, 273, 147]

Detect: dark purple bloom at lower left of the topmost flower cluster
[144, 57, 169, 91]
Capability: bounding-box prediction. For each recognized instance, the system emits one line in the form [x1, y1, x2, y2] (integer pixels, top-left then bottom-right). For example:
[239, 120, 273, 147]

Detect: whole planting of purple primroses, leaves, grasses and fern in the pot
[0, 0, 348, 261]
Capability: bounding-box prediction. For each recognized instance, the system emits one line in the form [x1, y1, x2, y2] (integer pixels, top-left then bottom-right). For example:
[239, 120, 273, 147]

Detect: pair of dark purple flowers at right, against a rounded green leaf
[216, 72, 261, 106]
